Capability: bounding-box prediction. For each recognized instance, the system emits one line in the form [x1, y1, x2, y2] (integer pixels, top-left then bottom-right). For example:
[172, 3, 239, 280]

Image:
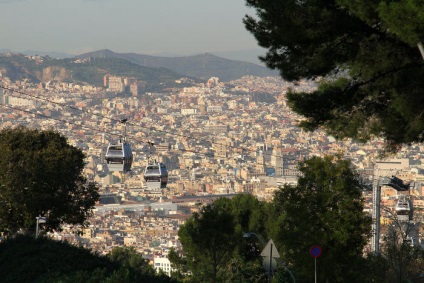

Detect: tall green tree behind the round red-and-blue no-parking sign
[273, 156, 371, 282]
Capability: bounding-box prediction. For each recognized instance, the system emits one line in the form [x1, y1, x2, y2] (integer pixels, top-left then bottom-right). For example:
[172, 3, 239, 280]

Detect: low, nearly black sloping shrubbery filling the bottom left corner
[0, 236, 175, 283]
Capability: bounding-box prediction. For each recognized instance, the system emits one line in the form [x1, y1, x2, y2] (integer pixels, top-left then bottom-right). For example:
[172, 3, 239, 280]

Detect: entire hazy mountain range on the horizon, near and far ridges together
[0, 49, 278, 90]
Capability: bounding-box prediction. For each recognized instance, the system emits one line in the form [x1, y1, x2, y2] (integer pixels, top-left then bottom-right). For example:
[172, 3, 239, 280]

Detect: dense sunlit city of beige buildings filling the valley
[0, 58, 424, 274]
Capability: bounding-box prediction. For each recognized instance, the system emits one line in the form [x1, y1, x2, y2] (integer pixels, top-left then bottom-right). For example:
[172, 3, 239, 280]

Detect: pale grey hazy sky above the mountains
[0, 0, 259, 55]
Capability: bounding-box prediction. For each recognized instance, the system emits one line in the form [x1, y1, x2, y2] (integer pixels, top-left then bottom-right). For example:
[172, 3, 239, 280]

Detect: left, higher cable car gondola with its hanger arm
[105, 119, 133, 172]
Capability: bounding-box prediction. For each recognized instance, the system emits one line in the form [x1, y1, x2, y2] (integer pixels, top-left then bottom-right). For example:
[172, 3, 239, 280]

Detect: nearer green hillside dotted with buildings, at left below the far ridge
[0, 53, 190, 91]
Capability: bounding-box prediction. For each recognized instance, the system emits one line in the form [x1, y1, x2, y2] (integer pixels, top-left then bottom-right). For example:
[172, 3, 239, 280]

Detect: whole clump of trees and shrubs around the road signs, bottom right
[173, 156, 424, 283]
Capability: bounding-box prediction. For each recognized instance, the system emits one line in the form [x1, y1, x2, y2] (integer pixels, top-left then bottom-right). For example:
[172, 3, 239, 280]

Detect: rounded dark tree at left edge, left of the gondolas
[0, 127, 99, 235]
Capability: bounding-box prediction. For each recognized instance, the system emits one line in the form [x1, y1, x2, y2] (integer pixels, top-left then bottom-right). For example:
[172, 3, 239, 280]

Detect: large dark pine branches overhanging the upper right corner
[244, 0, 424, 151]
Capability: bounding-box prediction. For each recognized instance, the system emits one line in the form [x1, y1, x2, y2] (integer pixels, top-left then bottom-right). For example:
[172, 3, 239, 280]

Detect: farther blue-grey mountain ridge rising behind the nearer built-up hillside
[76, 49, 278, 82]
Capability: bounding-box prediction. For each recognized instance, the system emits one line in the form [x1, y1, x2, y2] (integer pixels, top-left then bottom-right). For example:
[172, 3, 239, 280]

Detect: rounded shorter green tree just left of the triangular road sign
[173, 194, 266, 282]
